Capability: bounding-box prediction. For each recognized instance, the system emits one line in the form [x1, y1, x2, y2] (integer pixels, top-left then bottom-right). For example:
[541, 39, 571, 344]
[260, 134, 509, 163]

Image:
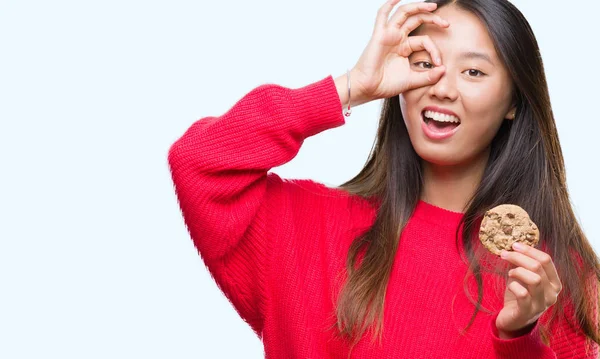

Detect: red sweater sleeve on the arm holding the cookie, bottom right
[490, 296, 599, 359]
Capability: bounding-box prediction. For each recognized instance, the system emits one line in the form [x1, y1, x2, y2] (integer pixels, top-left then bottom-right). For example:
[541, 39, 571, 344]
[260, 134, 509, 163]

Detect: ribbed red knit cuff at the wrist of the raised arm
[291, 75, 346, 137]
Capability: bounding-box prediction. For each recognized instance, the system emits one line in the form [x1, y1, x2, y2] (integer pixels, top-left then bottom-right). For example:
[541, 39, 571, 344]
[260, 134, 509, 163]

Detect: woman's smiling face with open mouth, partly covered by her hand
[399, 5, 513, 166]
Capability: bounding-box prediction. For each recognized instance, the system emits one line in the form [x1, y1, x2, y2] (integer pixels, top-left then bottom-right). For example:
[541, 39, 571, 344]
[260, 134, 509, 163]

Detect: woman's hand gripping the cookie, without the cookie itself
[496, 243, 562, 339]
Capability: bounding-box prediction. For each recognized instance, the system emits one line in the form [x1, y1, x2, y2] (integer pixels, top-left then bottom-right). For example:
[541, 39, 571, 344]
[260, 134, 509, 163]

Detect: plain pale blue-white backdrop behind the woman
[0, 0, 600, 359]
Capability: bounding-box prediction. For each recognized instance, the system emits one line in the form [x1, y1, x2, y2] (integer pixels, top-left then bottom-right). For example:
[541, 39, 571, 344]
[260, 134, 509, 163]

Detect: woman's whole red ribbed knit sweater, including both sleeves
[168, 76, 598, 359]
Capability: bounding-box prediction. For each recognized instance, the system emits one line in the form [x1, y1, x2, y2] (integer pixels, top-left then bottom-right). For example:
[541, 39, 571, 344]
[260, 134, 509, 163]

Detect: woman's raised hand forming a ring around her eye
[350, 0, 450, 102]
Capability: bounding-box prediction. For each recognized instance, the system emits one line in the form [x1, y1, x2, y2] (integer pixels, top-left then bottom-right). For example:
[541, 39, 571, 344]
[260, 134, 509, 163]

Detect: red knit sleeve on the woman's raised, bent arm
[168, 76, 345, 337]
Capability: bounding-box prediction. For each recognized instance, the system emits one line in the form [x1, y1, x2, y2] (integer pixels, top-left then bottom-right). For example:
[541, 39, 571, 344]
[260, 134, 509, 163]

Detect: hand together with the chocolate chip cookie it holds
[479, 205, 562, 339]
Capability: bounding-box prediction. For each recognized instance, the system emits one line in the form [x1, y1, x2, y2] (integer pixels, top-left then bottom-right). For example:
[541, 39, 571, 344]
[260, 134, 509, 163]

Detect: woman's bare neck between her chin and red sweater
[421, 149, 489, 213]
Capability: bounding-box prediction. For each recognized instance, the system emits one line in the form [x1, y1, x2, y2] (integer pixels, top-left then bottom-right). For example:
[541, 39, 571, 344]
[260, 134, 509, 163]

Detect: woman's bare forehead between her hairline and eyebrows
[412, 5, 498, 60]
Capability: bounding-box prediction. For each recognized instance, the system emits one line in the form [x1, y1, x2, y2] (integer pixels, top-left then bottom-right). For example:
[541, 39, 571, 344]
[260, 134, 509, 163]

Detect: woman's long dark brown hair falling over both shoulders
[336, 0, 600, 354]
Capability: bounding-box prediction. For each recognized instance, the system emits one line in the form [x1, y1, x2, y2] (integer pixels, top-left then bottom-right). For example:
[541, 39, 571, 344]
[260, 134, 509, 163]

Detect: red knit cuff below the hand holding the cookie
[490, 312, 546, 359]
